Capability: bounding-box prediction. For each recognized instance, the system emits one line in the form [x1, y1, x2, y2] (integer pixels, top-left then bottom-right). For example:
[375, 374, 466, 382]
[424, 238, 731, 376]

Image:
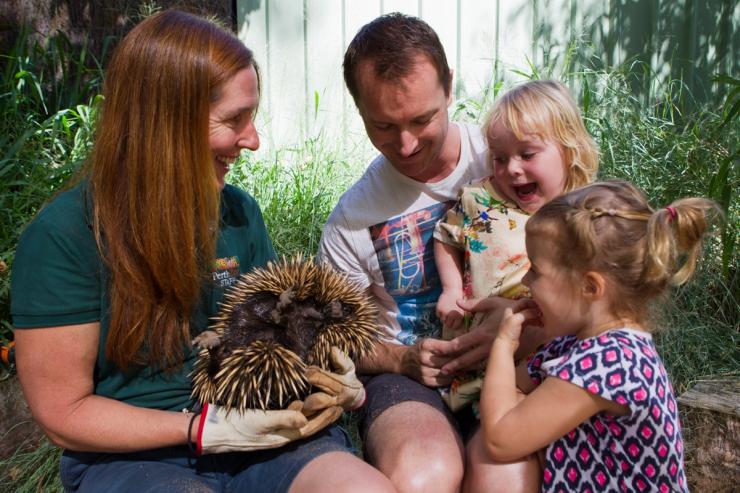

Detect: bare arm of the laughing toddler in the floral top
[434, 240, 463, 333]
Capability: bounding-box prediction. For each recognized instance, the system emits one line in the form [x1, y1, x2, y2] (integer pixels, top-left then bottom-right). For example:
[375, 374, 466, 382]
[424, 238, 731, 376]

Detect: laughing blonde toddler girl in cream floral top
[434, 80, 598, 410]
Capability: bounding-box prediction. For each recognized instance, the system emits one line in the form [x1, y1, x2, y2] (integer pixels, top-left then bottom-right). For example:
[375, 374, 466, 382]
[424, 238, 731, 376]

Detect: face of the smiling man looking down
[356, 55, 456, 182]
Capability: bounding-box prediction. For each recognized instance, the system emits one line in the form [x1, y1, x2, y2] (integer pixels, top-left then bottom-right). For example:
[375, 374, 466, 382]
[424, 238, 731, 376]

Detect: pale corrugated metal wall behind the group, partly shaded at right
[236, 0, 740, 149]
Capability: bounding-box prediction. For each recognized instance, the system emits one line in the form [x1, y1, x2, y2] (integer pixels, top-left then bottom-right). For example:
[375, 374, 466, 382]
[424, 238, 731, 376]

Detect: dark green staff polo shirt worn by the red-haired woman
[11, 182, 275, 410]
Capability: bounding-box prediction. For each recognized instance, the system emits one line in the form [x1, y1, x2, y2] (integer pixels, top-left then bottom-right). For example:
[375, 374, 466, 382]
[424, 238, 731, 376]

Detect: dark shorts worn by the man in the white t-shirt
[357, 373, 479, 443]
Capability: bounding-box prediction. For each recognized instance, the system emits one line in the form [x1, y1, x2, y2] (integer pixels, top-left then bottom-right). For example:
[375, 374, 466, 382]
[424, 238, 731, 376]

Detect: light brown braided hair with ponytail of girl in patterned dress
[526, 180, 721, 321]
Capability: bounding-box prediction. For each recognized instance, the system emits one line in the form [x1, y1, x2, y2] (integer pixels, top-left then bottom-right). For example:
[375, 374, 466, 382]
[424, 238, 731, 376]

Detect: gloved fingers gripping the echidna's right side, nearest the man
[303, 346, 365, 414]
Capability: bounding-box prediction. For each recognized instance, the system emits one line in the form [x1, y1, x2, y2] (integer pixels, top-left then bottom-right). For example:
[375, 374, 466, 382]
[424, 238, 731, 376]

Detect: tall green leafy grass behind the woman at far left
[0, 32, 103, 342]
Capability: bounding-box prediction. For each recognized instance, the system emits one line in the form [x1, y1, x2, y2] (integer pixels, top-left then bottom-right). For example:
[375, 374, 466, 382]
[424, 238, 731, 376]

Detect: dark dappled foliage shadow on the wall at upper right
[513, 0, 740, 108]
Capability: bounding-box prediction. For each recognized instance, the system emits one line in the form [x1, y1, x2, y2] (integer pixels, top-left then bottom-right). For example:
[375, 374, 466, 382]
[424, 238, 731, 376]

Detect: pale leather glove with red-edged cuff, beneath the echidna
[196, 403, 342, 455]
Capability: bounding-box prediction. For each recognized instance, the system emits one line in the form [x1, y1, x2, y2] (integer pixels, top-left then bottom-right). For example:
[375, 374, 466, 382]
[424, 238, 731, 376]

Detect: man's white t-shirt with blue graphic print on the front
[318, 123, 491, 344]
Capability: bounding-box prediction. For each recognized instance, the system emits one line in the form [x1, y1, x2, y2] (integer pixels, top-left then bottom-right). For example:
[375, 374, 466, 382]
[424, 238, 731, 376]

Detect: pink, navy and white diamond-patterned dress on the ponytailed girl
[528, 329, 688, 493]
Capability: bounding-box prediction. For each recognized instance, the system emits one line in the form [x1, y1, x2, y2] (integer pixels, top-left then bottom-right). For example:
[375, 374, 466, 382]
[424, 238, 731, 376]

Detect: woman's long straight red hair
[86, 10, 256, 369]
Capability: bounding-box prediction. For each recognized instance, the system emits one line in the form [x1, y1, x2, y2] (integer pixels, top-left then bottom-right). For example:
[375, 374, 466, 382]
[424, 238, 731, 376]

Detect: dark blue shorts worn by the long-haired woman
[60, 426, 354, 493]
